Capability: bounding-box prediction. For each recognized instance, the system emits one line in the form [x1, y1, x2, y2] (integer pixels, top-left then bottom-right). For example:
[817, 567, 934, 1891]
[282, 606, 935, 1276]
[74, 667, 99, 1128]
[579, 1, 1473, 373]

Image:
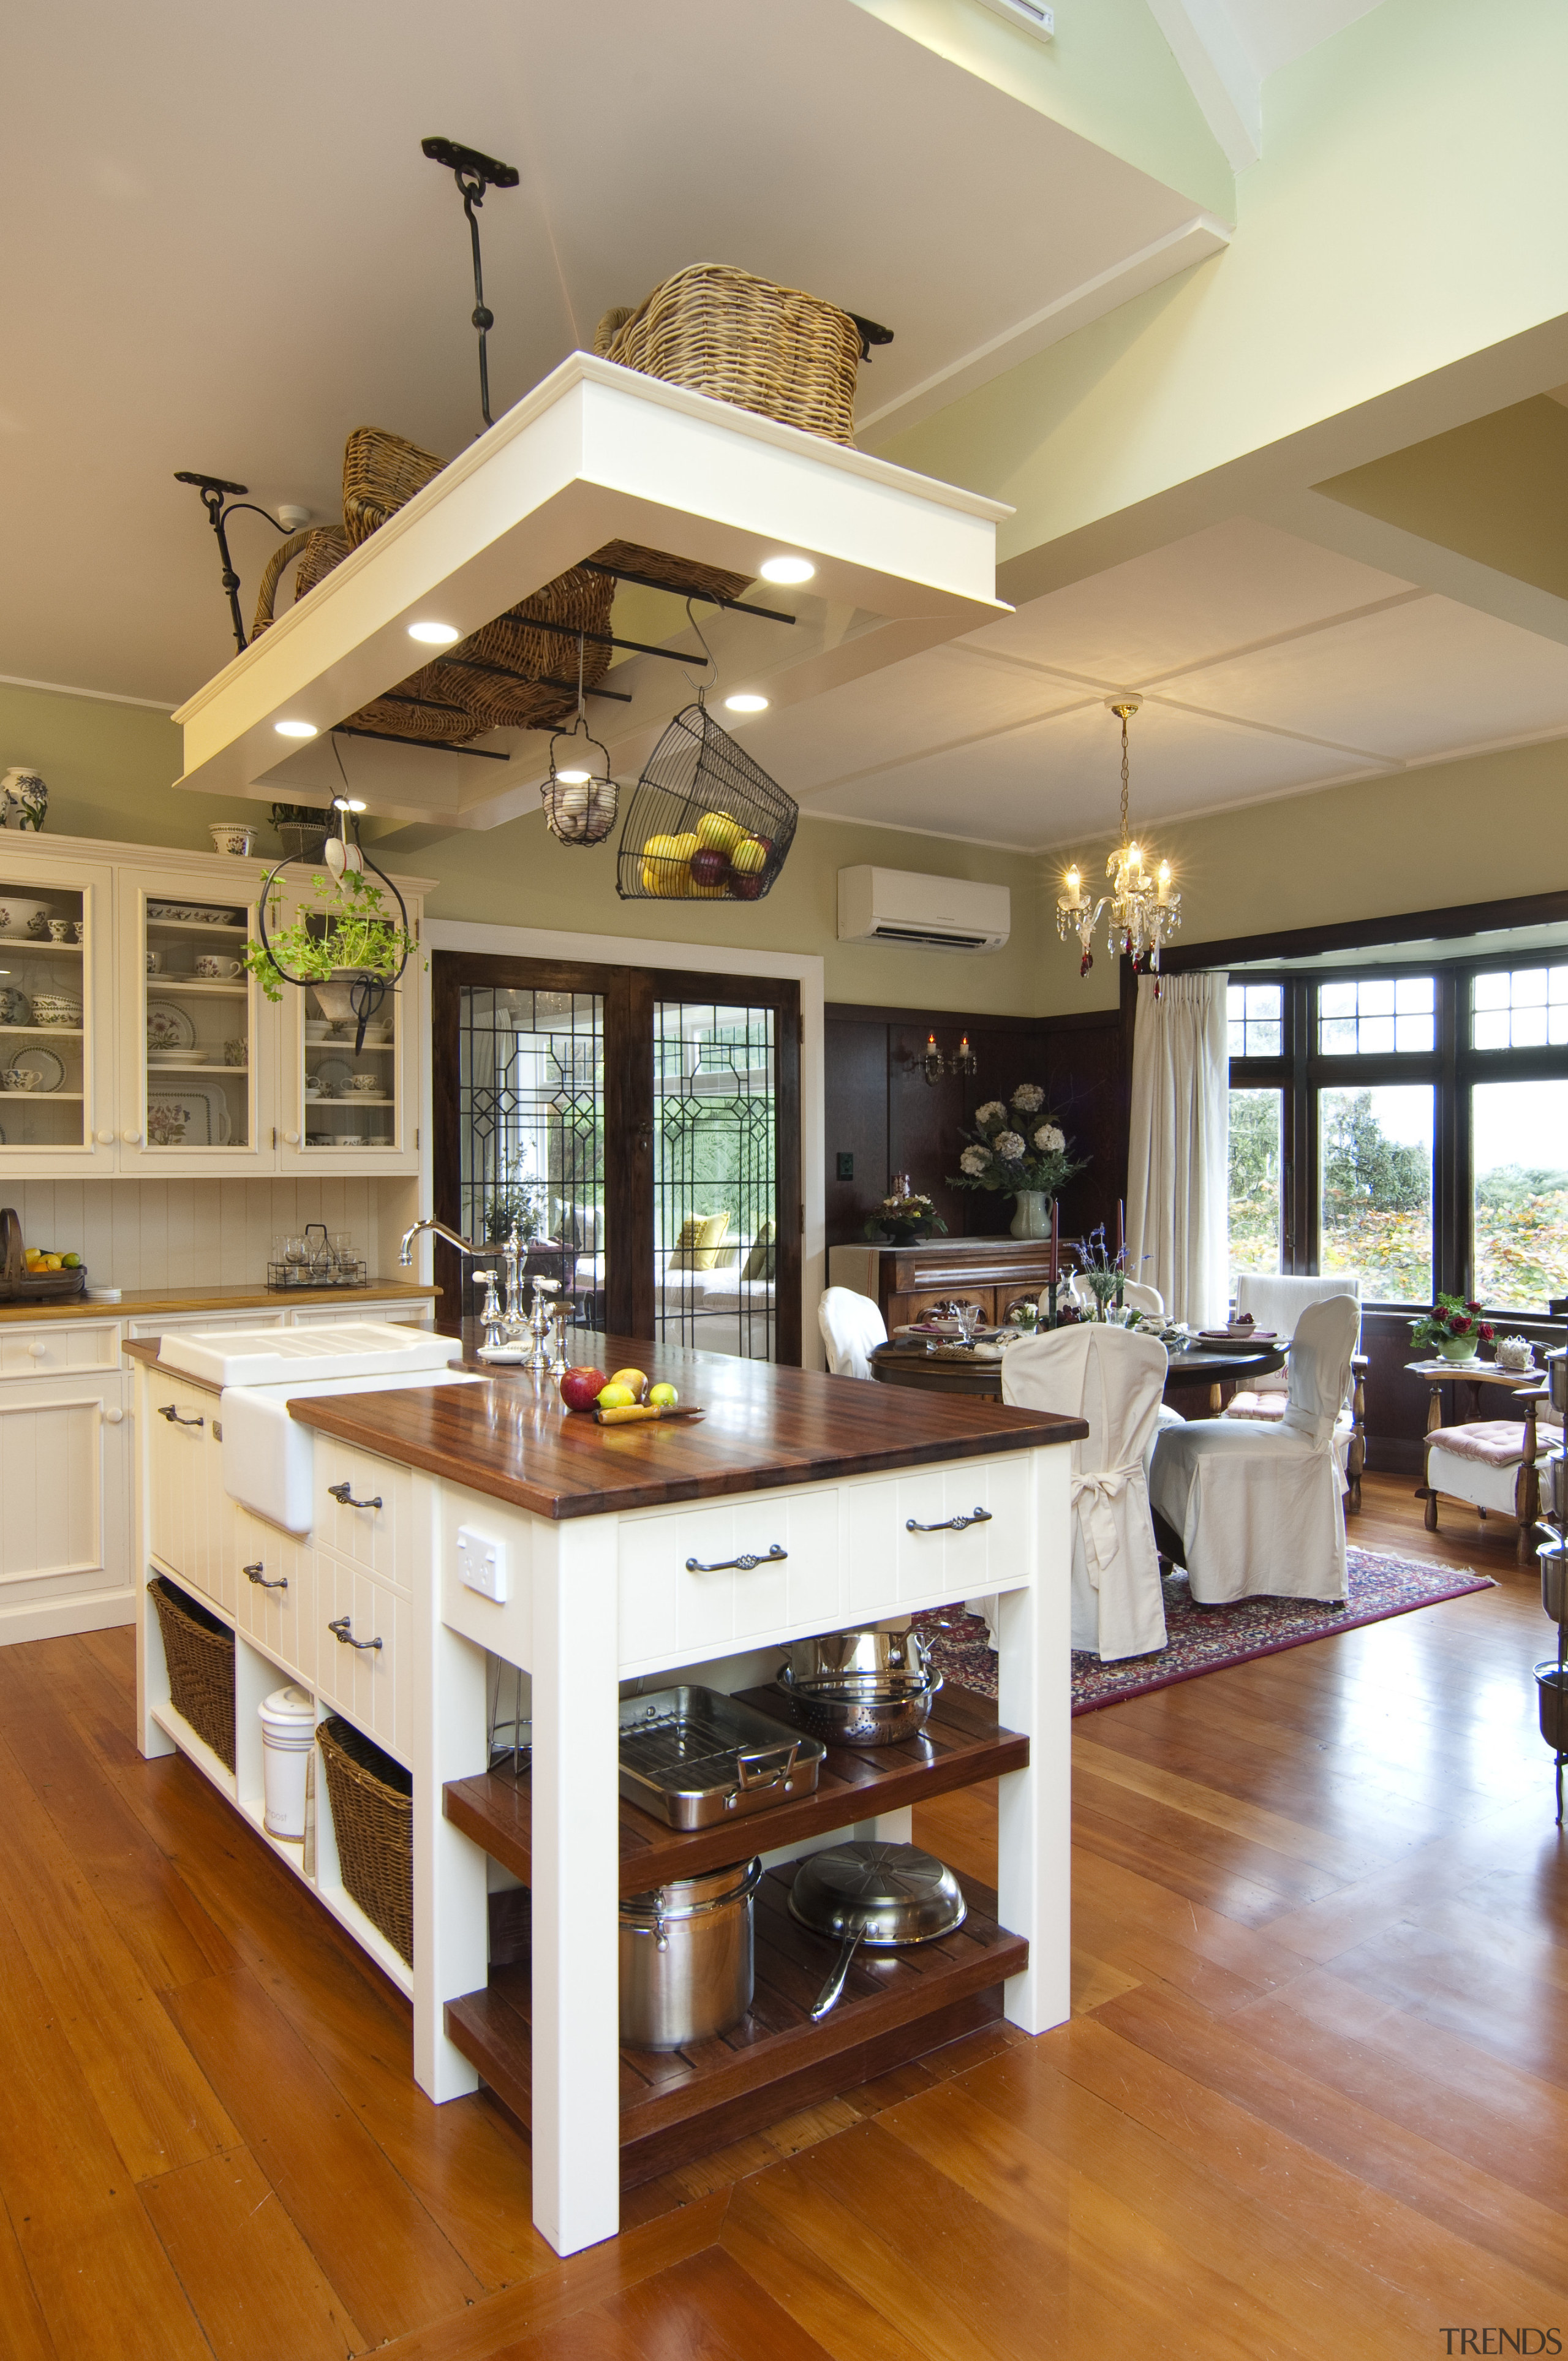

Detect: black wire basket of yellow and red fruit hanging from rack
[616, 689, 801, 902]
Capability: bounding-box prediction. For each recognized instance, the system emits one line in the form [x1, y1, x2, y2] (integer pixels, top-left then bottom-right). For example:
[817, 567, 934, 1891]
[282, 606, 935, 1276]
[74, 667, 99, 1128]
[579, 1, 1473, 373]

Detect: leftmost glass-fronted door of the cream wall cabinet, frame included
[0, 855, 116, 1176]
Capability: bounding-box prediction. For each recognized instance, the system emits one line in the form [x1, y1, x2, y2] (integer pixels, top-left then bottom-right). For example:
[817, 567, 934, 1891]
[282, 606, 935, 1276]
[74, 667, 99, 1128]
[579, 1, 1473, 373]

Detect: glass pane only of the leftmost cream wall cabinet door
[0, 878, 92, 1162]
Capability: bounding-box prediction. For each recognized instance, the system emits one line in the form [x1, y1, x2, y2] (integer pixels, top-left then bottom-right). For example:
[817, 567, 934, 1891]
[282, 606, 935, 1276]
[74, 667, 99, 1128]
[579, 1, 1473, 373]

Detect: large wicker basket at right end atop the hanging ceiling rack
[593, 262, 859, 444]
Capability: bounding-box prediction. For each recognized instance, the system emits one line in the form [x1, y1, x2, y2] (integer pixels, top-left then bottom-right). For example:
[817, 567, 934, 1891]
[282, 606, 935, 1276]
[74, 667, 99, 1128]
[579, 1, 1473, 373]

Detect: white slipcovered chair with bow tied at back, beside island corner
[1001, 1320, 1167, 1662]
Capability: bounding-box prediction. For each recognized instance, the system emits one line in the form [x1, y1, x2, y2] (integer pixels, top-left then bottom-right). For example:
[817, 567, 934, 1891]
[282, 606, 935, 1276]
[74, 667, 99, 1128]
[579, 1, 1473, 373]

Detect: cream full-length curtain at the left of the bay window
[1126, 975, 1231, 1327]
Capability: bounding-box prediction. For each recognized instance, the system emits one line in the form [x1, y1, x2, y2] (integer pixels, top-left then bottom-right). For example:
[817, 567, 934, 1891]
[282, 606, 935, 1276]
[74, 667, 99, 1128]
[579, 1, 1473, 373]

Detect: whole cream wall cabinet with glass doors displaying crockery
[0, 829, 420, 1180]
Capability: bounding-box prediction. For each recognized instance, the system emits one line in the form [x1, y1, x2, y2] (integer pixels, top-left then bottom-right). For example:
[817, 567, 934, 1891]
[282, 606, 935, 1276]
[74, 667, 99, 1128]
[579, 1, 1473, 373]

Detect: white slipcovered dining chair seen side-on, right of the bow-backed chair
[1150, 1296, 1360, 1606]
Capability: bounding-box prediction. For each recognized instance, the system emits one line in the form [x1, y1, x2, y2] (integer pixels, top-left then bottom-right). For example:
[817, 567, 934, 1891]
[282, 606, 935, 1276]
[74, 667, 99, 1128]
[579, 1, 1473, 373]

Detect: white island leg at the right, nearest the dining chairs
[997, 1449, 1072, 2033]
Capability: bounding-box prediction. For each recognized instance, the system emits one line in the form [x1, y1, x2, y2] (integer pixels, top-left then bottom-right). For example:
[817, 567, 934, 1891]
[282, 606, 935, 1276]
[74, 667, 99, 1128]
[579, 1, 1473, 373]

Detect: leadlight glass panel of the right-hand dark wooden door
[654, 1001, 779, 1360]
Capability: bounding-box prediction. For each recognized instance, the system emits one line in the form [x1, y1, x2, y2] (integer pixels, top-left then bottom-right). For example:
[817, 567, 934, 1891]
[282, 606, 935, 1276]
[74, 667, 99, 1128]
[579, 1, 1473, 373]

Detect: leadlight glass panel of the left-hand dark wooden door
[458, 984, 605, 1327]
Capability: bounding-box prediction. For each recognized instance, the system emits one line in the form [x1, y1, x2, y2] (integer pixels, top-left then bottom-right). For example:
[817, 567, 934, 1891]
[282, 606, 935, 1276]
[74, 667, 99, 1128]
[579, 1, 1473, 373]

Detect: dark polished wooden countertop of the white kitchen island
[282, 1332, 1088, 1518]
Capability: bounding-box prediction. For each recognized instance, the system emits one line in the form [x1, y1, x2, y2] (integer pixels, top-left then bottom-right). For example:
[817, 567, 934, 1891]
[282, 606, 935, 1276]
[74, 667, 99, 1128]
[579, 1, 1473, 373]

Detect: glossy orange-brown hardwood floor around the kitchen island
[0, 1476, 1568, 2361]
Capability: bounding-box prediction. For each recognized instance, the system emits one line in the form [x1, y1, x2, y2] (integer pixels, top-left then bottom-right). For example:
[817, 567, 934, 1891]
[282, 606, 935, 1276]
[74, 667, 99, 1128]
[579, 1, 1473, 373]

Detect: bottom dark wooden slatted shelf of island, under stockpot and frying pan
[447, 1860, 1030, 2189]
